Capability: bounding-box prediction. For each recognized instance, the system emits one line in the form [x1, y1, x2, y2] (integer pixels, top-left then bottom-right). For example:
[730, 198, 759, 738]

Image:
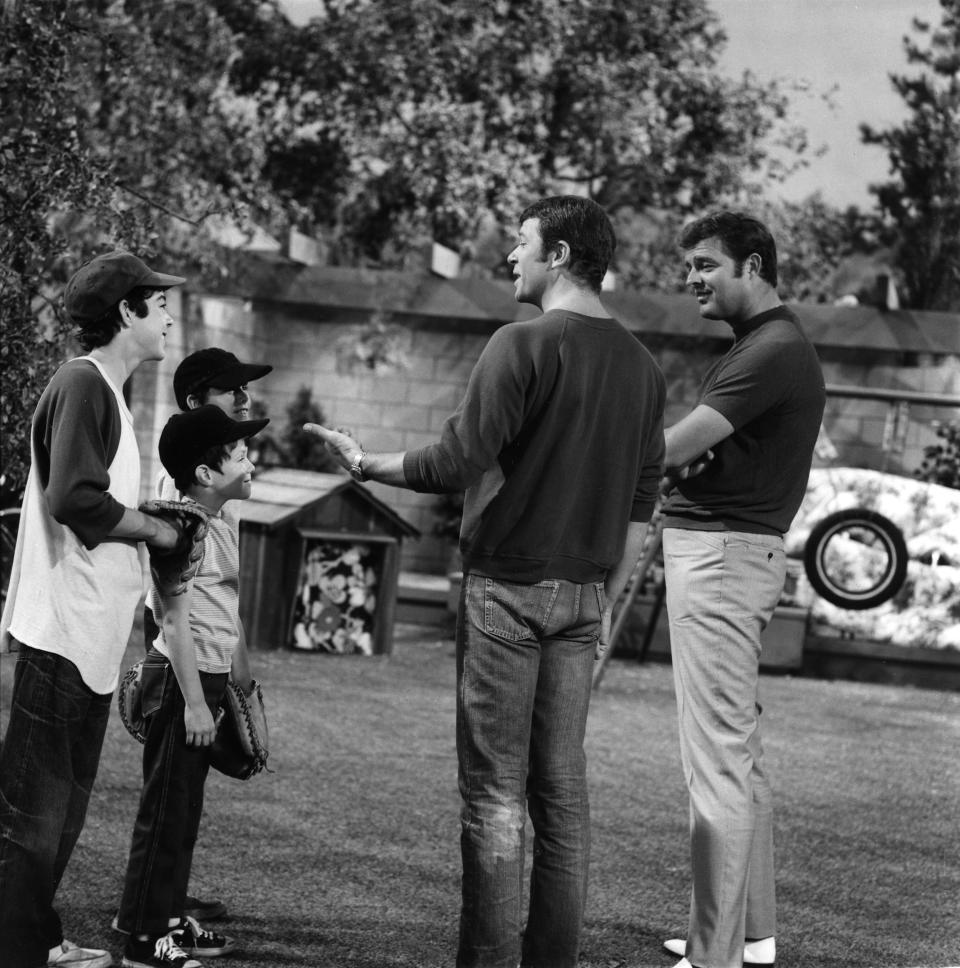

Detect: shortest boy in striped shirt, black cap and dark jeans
[116, 405, 269, 968]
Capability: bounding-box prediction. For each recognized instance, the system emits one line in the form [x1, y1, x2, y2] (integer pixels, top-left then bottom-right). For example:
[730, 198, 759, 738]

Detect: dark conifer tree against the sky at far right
[860, 0, 960, 310]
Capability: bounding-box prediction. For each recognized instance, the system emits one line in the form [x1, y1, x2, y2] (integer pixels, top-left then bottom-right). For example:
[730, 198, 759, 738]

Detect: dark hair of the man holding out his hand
[520, 195, 617, 292]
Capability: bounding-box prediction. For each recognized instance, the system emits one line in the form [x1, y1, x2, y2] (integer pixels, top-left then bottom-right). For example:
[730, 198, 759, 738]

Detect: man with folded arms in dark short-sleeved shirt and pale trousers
[663, 212, 825, 968]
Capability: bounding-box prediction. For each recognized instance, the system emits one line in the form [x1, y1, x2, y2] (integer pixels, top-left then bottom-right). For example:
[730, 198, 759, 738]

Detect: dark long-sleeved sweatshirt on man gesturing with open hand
[403, 310, 666, 584]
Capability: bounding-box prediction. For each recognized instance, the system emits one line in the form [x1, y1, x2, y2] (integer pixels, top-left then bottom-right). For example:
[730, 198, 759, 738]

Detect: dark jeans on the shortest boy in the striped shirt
[117, 649, 227, 937]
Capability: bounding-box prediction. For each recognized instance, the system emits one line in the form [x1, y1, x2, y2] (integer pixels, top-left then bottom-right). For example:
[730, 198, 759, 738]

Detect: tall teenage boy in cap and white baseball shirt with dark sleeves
[0, 251, 186, 968]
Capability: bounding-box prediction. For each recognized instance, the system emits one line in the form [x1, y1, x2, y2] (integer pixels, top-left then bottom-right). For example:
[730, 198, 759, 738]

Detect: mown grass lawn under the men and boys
[0, 626, 960, 968]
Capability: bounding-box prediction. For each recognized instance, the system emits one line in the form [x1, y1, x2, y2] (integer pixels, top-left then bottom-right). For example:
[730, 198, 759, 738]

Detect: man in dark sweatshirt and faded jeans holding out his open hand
[306, 196, 665, 968]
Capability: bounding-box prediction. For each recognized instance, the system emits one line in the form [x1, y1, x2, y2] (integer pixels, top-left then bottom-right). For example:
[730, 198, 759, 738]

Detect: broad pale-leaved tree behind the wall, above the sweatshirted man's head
[232, 0, 806, 265]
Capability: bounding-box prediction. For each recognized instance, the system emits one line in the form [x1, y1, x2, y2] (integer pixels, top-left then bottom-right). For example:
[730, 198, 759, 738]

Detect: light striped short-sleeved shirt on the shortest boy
[147, 498, 240, 672]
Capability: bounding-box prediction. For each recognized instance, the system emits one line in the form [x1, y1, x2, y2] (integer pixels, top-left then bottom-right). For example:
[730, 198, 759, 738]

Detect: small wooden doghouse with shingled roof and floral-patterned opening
[235, 467, 419, 654]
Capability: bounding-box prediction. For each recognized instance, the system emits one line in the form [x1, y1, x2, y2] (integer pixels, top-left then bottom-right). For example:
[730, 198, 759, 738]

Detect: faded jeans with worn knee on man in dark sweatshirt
[457, 575, 603, 968]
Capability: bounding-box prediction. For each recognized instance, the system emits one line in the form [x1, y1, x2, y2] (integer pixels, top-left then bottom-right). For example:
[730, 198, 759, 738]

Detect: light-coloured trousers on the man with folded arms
[663, 528, 786, 968]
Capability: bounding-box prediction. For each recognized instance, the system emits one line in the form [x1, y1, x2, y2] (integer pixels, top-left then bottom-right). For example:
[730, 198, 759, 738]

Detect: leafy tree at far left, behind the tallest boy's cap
[0, 0, 284, 500]
